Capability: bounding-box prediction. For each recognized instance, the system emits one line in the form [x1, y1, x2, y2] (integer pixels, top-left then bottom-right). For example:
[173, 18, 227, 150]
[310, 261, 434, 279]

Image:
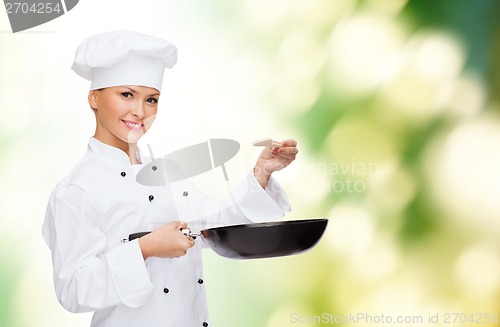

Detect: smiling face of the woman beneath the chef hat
[89, 85, 160, 149]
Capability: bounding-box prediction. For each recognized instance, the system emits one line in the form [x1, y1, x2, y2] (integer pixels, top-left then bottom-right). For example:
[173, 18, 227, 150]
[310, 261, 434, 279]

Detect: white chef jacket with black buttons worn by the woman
[42, 138, 290, 327]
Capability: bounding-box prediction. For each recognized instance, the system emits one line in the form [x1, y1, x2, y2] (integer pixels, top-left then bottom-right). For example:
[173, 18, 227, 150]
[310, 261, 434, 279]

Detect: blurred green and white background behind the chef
[0, 0, 500, 327]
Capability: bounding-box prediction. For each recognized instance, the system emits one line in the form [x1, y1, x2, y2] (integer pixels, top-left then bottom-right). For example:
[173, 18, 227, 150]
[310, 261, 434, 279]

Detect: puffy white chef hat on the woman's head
[71, 30, 177, 90]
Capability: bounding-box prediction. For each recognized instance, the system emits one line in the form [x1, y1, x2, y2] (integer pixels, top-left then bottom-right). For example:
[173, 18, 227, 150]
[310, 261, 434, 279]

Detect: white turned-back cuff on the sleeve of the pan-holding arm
[105, 239, 153, 308]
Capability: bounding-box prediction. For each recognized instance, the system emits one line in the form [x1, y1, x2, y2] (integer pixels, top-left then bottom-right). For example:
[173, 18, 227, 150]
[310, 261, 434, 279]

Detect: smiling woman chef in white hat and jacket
[43, 31, 297, 327]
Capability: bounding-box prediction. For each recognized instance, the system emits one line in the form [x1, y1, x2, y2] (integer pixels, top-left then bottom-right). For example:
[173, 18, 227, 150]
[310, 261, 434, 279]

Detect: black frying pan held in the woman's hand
[129, 219, 328, 259]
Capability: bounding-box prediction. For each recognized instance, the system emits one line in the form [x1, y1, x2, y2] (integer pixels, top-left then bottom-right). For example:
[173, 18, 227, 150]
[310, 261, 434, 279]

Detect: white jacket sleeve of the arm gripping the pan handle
[42, 185, 153, 312]
